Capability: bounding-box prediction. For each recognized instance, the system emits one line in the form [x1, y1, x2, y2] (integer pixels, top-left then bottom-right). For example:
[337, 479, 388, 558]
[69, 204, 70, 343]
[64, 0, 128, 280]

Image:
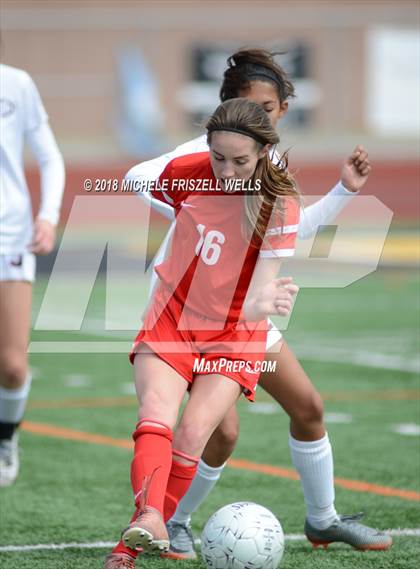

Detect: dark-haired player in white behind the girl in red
[107, 49, 392, 559]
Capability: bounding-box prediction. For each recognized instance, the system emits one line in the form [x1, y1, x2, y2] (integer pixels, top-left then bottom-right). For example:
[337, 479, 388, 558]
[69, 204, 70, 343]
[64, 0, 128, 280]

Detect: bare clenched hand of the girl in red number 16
[255, 277, 299, 318]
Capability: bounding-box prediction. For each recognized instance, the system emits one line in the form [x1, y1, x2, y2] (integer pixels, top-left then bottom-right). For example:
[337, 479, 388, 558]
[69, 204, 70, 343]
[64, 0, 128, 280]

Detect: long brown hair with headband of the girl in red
[206, 98, 299, 243]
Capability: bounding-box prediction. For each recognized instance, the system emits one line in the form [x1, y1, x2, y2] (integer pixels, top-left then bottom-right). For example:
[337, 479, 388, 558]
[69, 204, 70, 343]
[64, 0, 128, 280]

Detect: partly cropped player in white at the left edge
[0, 64, 65, 486]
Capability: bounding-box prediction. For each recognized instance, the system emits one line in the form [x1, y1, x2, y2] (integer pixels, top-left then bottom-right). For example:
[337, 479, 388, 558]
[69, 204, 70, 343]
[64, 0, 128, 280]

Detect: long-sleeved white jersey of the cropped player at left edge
[0, 64, 64, 255]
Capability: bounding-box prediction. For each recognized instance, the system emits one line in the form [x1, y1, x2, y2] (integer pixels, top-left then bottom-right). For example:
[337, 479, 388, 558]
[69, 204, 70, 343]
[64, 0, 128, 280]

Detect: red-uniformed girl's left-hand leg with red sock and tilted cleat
[118, 346, 188, 553]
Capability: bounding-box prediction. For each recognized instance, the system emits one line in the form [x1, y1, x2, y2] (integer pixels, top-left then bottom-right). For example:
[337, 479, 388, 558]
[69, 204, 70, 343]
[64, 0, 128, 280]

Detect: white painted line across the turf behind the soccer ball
[0, 528, 420, 553]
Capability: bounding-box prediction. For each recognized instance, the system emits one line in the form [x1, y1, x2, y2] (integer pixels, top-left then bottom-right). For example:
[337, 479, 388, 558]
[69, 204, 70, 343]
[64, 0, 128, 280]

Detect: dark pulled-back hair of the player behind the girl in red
[219, 49, 295, 102]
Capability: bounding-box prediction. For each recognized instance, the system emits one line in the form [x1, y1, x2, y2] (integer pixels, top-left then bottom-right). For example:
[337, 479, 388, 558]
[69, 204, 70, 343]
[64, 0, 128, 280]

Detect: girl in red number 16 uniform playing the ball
[105, 99, 300, 569]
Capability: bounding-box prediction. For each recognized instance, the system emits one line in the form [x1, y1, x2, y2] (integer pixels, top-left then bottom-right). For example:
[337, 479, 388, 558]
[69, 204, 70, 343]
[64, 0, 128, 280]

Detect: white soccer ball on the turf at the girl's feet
[201, 502, 284, 569]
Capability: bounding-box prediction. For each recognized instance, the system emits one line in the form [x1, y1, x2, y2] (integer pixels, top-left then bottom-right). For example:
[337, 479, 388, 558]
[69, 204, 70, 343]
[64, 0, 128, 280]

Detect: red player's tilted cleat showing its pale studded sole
[121, 506, 169, 553]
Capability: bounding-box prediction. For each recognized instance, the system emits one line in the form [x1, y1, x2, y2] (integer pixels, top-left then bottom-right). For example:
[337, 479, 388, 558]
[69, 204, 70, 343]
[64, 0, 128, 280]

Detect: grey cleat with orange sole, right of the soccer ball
[305, 512, 392, 551]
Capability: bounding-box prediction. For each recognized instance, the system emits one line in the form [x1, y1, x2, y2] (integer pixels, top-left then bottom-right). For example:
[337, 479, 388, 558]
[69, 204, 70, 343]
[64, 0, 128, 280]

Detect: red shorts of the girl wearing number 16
[130, 286, 267, 401]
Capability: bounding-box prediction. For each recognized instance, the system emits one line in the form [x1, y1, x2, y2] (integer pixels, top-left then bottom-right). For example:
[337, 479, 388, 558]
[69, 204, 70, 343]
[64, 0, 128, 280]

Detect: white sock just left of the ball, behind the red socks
[171, 460, 225, 523]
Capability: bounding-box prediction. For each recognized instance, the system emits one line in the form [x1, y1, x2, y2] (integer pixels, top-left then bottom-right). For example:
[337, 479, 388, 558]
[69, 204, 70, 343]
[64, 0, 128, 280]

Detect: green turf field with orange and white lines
[0, 270, 420, 569]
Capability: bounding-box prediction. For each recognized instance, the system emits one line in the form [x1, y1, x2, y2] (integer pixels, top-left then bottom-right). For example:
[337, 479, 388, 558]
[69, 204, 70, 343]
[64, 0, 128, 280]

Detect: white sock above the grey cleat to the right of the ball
[289, 434, 337, 529]
